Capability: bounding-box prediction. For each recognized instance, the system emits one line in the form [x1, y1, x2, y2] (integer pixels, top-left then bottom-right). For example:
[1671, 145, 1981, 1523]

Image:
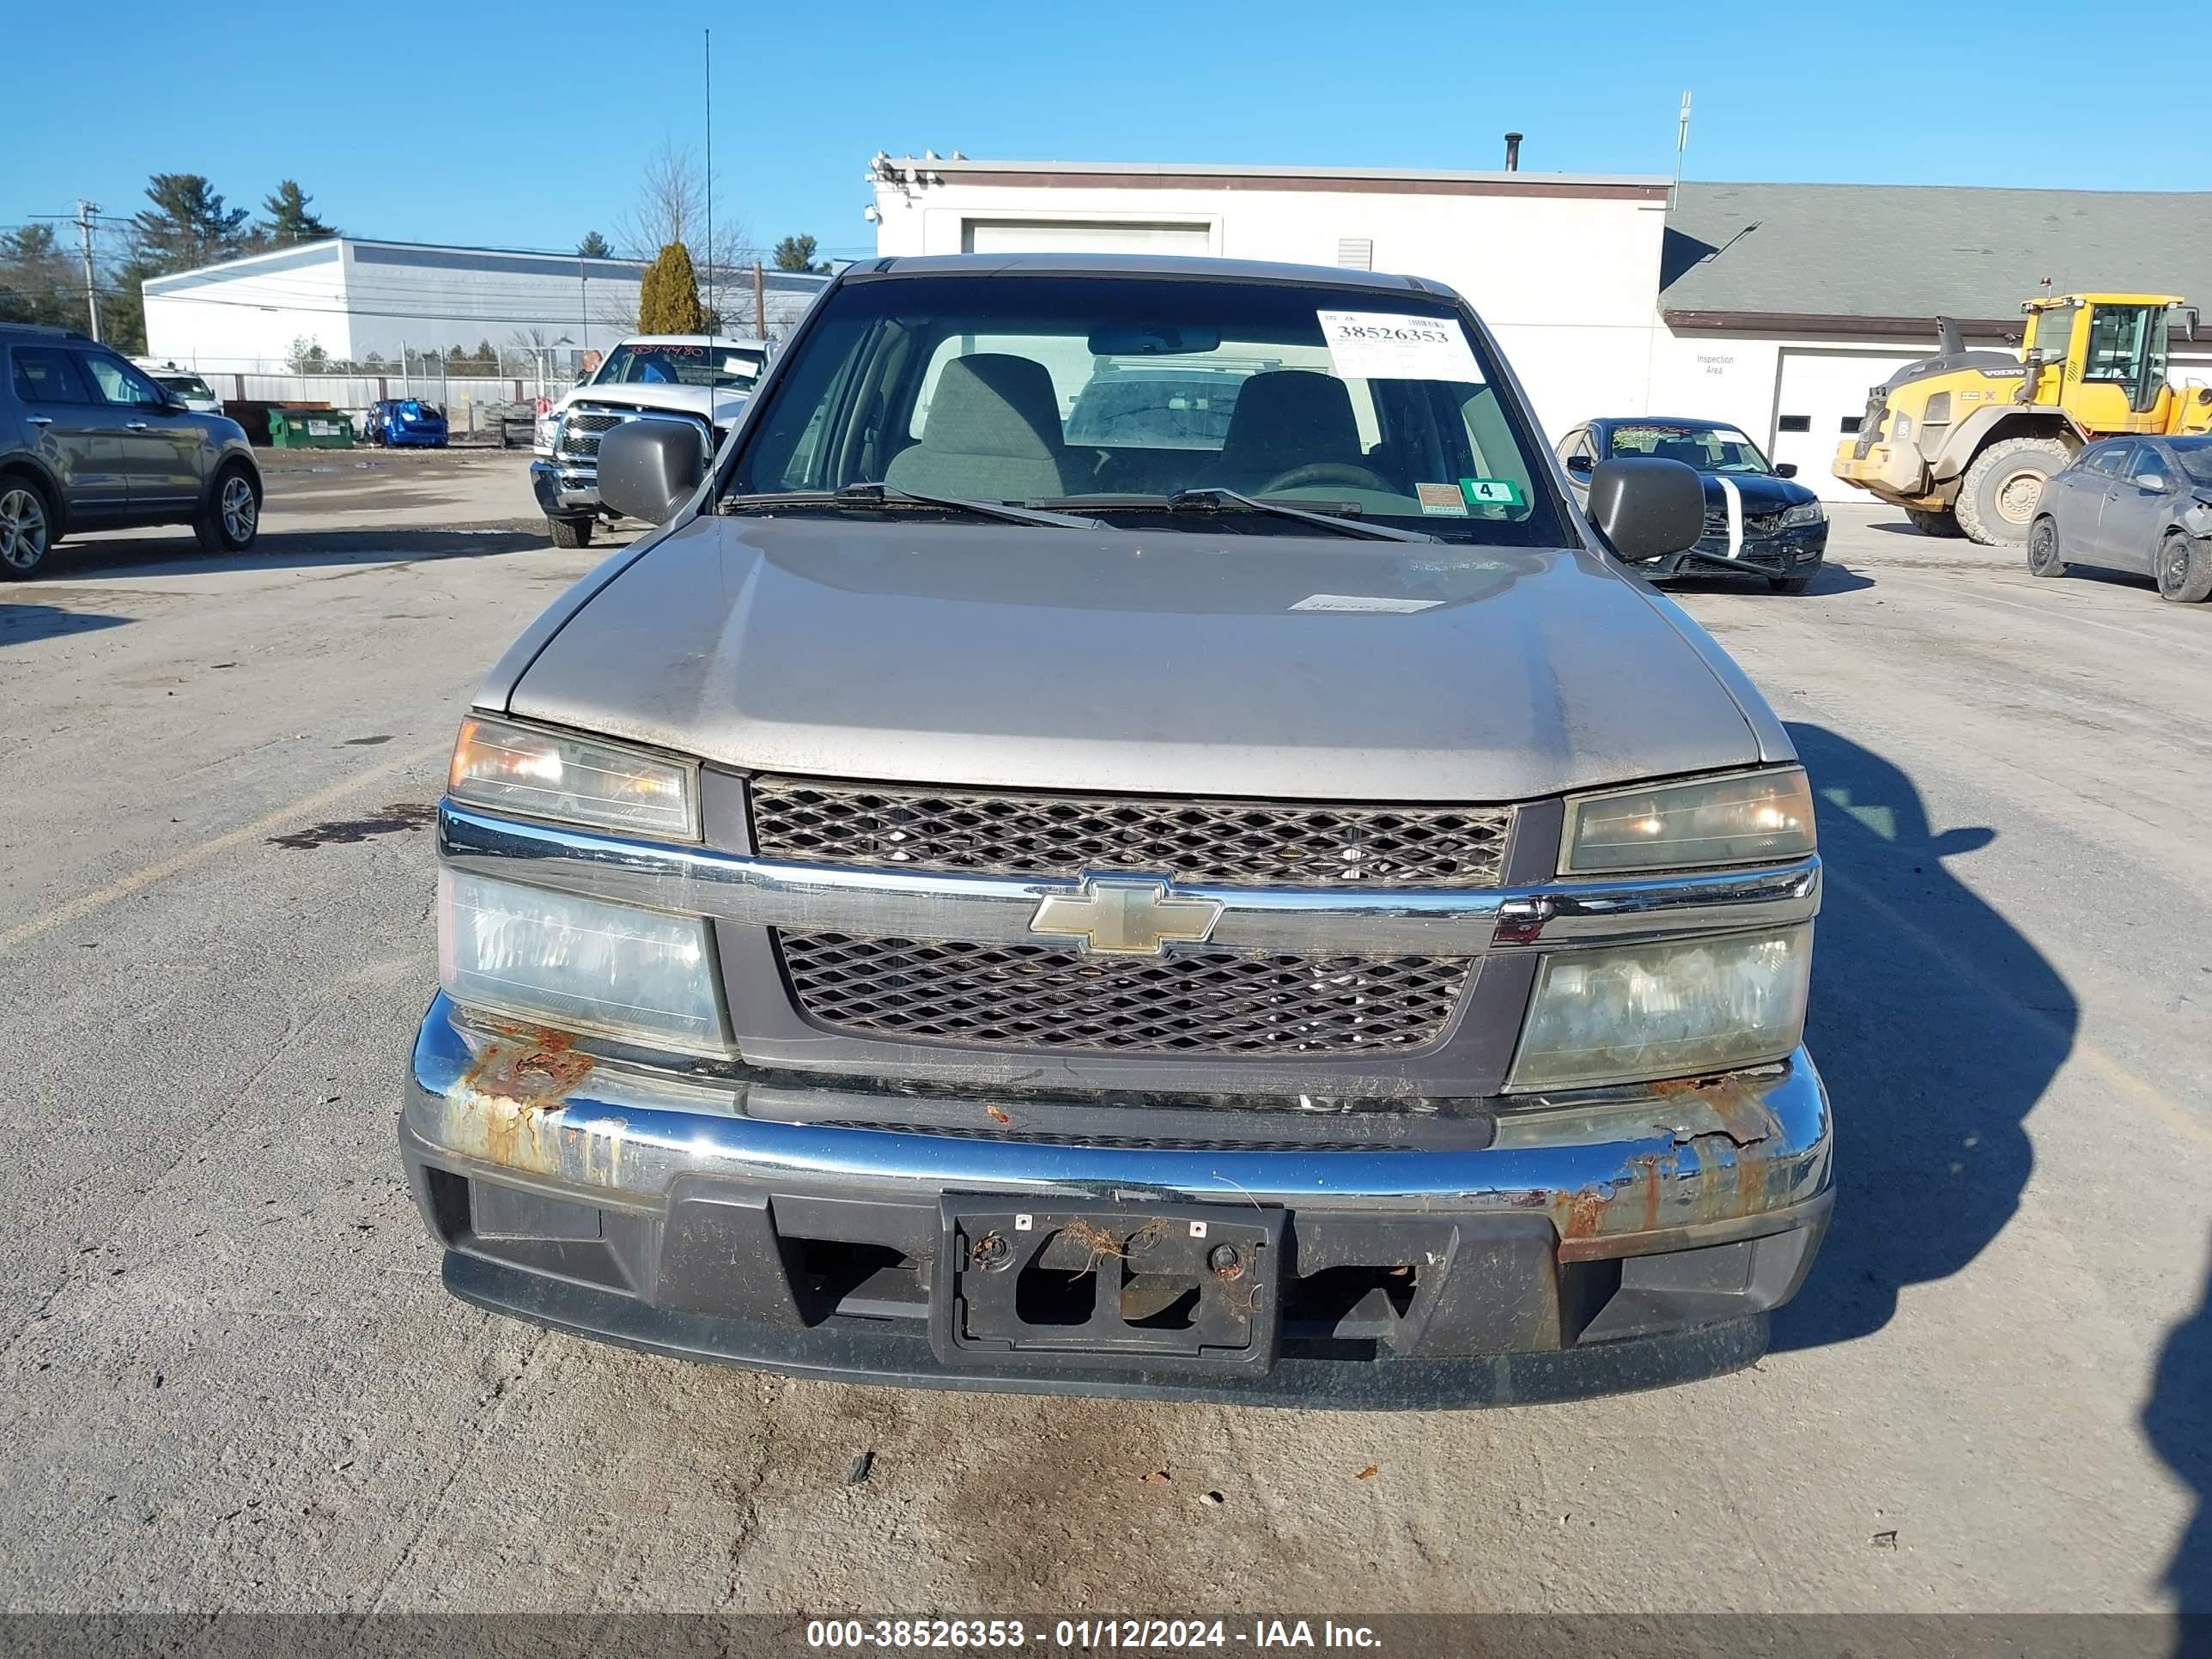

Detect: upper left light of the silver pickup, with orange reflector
[445, 714, 699, 841]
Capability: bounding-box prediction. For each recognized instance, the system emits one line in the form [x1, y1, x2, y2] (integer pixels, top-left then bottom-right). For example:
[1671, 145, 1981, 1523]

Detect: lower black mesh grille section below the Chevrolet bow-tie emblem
[776, 931, 1468, 1055]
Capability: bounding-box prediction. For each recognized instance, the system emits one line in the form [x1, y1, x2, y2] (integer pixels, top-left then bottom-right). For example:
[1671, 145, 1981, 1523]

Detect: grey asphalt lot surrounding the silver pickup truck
[0, 471, 2212, 1614]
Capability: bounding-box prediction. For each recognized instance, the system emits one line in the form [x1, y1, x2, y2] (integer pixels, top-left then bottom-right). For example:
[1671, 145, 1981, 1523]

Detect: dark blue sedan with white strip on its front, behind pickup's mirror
[1558, 416, 1827, 592]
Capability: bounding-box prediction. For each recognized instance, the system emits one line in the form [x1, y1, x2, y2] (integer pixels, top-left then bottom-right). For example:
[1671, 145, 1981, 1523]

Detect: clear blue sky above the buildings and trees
[0, 0, 2212, 257]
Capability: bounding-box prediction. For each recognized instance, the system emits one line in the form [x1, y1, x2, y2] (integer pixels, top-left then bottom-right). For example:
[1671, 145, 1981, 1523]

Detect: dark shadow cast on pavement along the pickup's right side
[1774, 723, 2081, 1349]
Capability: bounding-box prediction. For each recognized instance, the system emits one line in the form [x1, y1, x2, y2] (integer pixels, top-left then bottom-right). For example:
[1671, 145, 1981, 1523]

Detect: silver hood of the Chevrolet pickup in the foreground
[508, 518, 1763, 801]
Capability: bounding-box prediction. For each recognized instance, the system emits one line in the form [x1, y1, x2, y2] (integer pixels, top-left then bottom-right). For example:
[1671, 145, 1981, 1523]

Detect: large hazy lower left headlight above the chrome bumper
[438, 869, 730, 1055]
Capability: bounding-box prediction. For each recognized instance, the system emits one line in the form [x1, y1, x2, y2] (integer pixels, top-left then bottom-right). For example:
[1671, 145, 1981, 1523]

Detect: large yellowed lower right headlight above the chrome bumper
[1506, 922, 1812, 1093]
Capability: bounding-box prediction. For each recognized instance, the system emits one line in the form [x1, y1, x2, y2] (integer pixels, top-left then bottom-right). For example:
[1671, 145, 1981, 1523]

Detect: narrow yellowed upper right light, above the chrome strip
[1559, 765, 1814, 876]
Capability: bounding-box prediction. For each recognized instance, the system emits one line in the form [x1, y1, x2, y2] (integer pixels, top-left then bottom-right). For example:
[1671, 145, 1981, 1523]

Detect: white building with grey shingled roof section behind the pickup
[872, 155, 2212, 500]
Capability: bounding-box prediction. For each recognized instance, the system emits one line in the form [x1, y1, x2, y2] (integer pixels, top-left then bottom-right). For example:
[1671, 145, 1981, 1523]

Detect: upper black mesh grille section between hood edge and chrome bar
[752, 776, 1513, 887]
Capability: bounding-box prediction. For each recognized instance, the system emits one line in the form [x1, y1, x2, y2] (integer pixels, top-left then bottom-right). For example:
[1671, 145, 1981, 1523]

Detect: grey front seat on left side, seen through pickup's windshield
[883, 352, 1075, 502]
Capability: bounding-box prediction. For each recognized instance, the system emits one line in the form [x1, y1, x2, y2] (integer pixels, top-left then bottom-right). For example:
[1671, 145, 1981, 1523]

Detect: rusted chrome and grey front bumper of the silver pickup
[400, 998, 1832, 1407]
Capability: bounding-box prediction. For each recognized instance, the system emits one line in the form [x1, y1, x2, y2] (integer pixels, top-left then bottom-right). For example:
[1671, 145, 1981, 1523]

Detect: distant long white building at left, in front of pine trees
[143, 237, 827, 376]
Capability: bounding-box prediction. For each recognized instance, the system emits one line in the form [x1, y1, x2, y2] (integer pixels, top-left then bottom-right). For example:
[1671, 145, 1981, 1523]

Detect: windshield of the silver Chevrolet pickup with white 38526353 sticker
[726, 274, 1564, 546]
